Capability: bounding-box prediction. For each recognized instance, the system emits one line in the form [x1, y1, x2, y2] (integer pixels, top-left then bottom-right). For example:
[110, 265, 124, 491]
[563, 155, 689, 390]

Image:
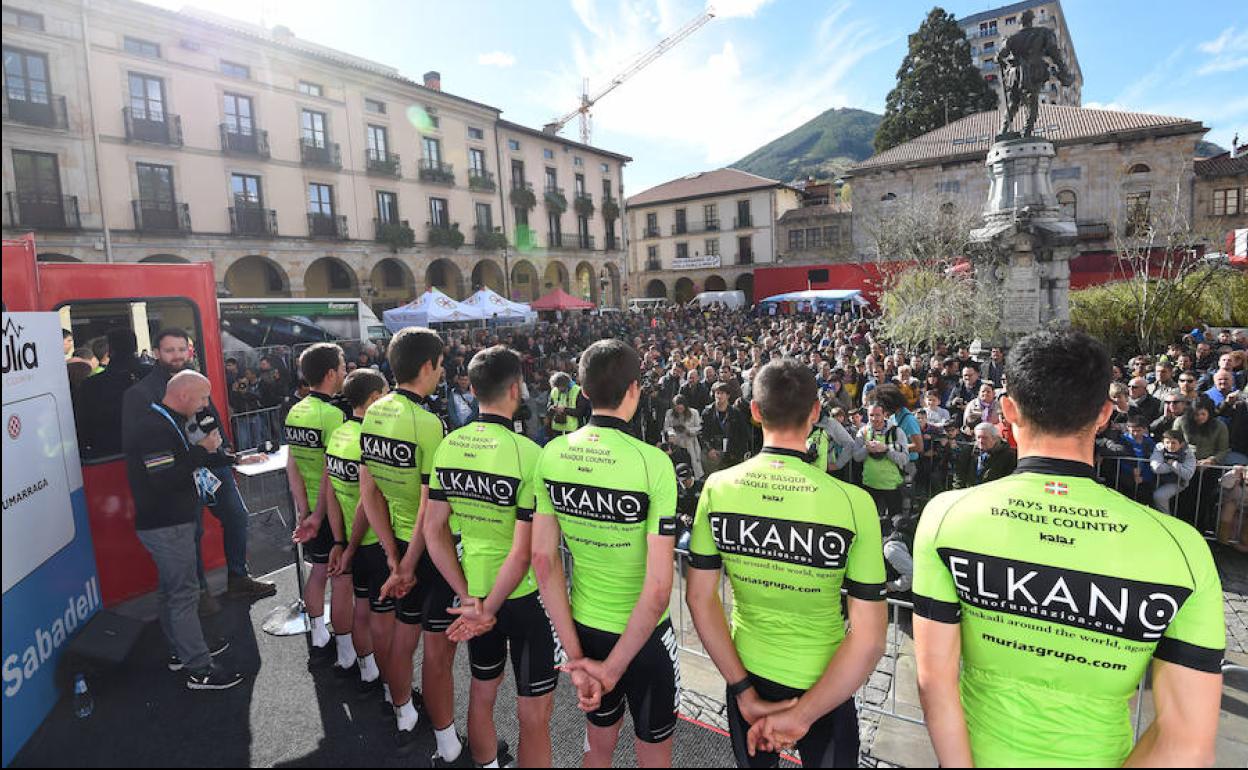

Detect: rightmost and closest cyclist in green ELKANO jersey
[914, 332, 1226, 768]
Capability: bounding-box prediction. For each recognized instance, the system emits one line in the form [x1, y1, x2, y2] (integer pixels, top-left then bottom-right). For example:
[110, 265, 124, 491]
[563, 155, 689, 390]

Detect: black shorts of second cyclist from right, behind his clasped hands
[726, 674, 859, 768]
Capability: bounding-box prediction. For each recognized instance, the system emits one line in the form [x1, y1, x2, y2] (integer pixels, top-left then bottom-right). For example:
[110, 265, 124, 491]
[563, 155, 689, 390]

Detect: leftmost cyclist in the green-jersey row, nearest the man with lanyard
[285, 342, 351, 663]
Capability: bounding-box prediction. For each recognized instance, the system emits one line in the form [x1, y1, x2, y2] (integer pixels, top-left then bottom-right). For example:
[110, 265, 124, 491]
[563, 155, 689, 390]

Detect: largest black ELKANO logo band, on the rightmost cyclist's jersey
[937, 548, 1192, 641]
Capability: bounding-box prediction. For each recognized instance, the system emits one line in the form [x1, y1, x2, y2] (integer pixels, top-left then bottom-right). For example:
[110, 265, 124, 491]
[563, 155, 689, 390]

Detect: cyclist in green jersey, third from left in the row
[359, 327, 462, 764]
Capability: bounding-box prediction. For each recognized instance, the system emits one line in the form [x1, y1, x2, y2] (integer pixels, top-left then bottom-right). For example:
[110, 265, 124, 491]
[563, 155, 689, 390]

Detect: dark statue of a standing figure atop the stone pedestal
[997, 9, 1073, 136]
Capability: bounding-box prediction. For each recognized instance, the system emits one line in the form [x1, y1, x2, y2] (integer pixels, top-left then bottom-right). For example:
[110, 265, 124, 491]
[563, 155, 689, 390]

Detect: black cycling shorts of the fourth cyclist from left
[468, 592, 563, 698]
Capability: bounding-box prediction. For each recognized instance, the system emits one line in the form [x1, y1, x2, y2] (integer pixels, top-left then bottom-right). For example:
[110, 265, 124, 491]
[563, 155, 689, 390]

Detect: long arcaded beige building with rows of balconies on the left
[2, 0, 630, 309]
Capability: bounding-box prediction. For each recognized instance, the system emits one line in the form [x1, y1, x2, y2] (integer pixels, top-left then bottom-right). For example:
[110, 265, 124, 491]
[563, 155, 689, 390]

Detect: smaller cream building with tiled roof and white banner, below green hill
[625, 168, 801, 302]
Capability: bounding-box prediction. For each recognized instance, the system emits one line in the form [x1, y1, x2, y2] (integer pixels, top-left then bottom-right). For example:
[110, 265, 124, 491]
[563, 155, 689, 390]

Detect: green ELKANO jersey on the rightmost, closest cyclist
[914, 457, 1226, 766]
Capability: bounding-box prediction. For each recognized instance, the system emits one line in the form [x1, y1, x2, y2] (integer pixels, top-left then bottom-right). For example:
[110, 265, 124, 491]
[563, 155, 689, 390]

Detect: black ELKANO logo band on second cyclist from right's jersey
[710, 513, 854, 569]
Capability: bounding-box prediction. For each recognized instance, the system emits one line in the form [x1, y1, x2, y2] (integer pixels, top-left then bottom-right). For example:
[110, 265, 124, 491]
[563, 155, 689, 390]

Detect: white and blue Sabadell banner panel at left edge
[0, 313, 101, 765]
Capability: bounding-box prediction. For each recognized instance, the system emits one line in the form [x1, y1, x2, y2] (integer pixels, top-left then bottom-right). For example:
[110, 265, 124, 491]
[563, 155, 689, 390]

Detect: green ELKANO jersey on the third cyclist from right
[533, 414, 676, 634]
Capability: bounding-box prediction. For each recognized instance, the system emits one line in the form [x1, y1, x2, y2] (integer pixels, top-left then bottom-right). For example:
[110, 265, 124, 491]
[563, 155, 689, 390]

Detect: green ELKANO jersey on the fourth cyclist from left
[429, 414, 542, 599]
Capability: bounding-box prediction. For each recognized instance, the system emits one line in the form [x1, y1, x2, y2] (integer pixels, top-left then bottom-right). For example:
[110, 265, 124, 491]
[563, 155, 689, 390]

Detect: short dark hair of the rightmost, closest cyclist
[1005, 332, 1112, 436]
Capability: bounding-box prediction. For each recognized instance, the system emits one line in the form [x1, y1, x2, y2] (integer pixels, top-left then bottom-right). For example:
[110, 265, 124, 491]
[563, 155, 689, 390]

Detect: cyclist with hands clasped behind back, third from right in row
[533, 339, 680, 768]
